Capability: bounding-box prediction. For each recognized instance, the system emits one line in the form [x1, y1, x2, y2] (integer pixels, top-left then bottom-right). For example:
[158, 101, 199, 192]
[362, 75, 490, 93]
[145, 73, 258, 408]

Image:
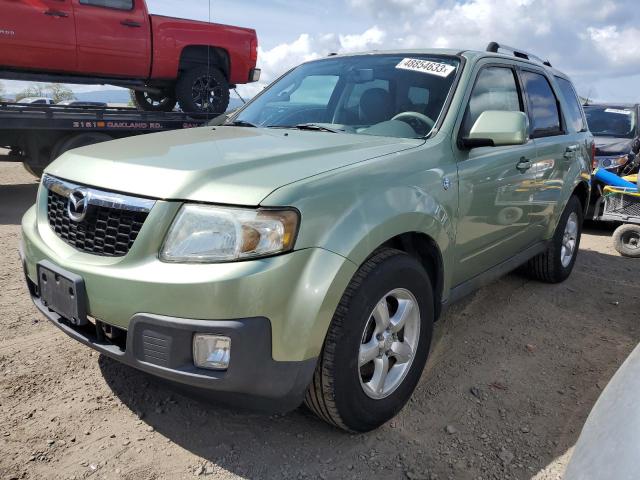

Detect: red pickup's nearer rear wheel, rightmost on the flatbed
[176, 65, 229, 117]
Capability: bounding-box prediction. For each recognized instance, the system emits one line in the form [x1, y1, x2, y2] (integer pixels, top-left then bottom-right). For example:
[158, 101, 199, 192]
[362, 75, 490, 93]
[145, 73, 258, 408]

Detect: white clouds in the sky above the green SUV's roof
[240, 0, 640, 98]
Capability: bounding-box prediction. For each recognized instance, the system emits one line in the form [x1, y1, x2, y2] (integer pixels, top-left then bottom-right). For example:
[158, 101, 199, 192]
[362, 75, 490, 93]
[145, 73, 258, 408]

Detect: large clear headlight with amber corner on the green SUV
[160, 205, 299, 263]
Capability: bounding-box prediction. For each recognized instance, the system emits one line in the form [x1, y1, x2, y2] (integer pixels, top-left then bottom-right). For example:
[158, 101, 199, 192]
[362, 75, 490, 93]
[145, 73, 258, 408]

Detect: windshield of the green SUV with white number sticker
[228, 54, 460, 138]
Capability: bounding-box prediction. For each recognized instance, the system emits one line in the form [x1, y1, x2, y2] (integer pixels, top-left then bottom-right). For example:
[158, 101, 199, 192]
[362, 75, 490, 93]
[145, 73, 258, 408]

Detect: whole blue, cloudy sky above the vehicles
[5, 0, 640, 101]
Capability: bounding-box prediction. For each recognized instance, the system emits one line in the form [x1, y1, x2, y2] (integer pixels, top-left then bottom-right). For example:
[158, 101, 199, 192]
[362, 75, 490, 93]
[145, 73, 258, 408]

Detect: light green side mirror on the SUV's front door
[462, 110, 529, 148]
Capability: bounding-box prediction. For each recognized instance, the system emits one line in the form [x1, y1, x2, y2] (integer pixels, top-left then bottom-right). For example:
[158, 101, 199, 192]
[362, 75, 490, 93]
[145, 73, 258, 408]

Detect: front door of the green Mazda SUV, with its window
[453, 63, 538, 285]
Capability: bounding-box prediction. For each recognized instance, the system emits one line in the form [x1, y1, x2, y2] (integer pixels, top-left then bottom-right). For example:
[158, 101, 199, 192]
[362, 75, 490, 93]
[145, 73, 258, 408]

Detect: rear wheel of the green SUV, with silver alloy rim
[525, 195, 584, 283]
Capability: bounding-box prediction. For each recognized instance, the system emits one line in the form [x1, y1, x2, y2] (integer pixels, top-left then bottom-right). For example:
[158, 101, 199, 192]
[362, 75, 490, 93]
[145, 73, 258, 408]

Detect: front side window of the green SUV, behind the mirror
[461, 67, 522, 137]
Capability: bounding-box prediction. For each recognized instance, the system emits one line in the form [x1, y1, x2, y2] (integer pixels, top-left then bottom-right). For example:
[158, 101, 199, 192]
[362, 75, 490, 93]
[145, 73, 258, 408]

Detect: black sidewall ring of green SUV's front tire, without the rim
[333, 254, 434, 431]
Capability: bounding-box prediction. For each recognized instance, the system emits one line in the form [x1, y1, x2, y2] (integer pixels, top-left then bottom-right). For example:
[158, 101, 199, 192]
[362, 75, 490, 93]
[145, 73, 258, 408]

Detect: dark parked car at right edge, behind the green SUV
[584, 103, 640, 173]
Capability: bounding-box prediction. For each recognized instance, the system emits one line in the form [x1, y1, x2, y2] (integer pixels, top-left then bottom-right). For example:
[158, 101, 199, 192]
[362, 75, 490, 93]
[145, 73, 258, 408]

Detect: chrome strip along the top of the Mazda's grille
[42, 174, 156, 213]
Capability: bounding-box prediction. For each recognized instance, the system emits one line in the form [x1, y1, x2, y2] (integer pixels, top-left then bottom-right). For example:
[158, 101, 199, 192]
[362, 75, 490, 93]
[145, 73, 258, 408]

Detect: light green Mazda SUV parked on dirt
[21, 44, 593, 431]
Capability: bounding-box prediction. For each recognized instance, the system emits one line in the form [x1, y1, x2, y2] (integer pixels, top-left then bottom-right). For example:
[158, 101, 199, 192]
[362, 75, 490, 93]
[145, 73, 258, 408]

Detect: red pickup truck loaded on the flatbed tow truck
[0, 0, 260, 114]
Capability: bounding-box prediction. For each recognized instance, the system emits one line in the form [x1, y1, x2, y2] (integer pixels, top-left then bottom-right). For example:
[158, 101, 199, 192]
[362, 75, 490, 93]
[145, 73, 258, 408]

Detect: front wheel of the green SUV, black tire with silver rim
[305, 248, 434, 432]
